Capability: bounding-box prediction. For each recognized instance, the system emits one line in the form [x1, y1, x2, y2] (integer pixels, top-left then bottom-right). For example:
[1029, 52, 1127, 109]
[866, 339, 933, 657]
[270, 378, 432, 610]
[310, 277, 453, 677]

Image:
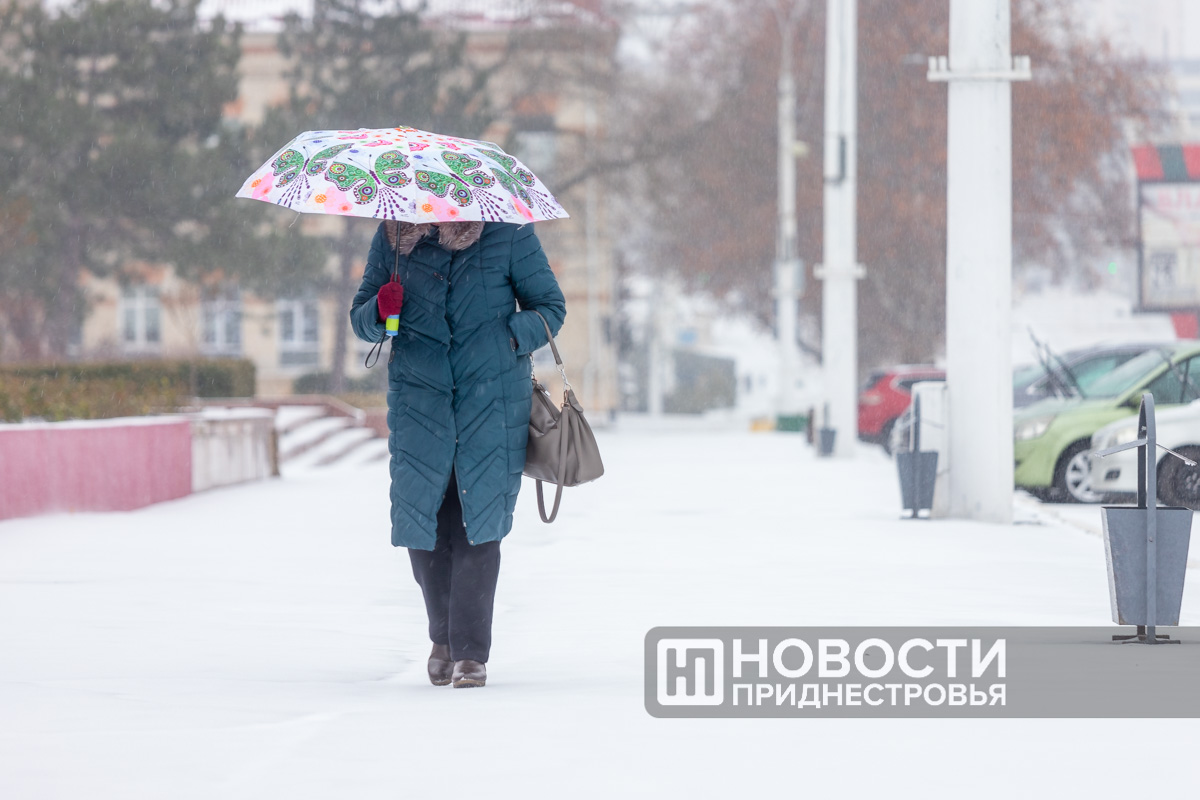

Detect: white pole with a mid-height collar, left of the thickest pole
[816, 0, 862, 457]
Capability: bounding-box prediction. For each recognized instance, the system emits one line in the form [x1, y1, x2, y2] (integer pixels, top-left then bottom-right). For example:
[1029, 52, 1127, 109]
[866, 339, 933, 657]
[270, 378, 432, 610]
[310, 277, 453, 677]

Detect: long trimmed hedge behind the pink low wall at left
[0, 359, 254, 422]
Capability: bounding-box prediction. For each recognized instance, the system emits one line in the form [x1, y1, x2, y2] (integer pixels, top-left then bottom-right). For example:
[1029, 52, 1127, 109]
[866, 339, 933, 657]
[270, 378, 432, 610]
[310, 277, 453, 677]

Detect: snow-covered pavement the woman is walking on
[0, 420, 1200, 800]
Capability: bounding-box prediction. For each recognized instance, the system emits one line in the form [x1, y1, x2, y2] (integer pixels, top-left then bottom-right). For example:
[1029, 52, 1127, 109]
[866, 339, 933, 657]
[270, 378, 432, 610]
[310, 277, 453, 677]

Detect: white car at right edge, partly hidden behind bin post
[1091, 399, 1200, 509]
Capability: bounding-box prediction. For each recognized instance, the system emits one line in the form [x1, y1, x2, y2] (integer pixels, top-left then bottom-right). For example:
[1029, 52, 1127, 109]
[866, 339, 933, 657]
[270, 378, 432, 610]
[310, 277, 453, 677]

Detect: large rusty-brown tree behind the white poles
[604, 0, 1164, 367]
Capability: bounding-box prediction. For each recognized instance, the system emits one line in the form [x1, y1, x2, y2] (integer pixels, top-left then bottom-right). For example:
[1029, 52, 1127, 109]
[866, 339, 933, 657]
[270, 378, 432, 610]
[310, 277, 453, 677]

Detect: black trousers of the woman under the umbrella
[408, 474, 500, 663]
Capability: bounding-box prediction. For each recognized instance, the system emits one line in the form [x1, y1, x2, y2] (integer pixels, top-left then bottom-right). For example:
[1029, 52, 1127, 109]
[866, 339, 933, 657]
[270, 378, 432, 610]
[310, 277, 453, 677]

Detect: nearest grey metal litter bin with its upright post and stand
[1092, 392, 1196, 644]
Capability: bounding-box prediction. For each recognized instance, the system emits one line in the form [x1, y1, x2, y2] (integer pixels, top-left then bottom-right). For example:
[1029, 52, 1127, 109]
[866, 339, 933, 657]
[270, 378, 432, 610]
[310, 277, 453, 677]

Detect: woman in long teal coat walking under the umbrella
[350, 221, 566, 687]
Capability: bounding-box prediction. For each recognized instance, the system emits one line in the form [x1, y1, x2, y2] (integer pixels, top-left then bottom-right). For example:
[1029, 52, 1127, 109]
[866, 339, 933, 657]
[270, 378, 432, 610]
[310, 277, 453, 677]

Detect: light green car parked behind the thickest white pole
[1013, 342, 1200, 503]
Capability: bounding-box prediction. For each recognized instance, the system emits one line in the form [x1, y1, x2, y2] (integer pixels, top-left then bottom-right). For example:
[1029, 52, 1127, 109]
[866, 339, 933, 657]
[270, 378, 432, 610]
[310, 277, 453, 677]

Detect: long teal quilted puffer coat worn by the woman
[350, 222, 566, 551]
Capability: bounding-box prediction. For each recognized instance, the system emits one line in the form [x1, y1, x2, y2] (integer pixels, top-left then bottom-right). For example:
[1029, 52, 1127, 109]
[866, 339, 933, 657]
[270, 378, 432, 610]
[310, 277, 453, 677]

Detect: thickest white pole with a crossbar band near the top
[929, 0, 1028, 524]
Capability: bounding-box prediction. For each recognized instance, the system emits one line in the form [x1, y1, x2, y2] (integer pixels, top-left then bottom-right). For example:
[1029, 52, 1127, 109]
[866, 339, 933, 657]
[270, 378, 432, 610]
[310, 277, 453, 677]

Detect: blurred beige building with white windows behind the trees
[79, 0, 617, 412]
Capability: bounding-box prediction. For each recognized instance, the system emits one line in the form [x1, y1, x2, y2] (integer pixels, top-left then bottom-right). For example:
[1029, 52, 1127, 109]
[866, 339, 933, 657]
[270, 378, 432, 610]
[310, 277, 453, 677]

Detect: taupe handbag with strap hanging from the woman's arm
[524, 311, 604, 523]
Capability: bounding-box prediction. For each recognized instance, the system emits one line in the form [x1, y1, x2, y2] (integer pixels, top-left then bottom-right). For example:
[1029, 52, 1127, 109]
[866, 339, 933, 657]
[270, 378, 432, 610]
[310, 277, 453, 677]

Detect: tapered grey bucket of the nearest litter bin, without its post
[1102, 506, 1192, 625]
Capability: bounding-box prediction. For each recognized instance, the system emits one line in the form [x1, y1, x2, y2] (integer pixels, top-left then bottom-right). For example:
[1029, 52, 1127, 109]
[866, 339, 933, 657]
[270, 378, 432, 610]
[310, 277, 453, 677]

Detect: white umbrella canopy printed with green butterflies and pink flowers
[238, 127, 569, 224]
